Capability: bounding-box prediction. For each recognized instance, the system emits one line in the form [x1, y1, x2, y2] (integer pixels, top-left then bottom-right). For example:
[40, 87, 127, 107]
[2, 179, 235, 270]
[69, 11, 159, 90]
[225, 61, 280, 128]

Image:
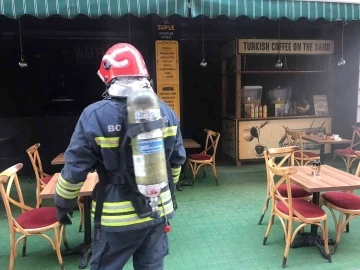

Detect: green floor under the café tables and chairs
[0, 157, 360, 270]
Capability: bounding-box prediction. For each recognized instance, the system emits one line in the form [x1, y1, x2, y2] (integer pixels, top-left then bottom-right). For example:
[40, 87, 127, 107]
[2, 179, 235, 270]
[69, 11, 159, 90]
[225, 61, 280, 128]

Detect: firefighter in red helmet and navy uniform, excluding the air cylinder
[55, 43, 186, 270]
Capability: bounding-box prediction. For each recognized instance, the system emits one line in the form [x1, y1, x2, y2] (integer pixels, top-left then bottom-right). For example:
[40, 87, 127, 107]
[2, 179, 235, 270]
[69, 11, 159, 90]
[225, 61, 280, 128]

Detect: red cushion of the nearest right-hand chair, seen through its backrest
[276, 199, 325, 218]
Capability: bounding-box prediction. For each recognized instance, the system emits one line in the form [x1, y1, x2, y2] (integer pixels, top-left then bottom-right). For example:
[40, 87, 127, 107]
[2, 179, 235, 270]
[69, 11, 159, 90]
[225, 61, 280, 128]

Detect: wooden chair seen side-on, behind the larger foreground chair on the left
[26, 143, 52, 208]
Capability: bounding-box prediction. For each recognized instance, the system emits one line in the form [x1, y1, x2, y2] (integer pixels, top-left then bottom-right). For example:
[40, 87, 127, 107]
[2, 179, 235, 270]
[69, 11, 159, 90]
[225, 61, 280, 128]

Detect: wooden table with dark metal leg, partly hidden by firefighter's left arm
[40, 173, 99, 269]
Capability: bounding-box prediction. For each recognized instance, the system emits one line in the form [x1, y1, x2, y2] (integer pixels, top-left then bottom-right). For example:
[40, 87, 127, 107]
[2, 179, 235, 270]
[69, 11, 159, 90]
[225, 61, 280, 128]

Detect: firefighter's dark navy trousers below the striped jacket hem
[90, 222, 169, 270]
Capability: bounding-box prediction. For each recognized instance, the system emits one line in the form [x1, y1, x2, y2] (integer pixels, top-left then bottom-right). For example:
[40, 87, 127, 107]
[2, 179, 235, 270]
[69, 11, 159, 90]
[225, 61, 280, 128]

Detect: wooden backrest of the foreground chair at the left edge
[0, 163, 32, 231]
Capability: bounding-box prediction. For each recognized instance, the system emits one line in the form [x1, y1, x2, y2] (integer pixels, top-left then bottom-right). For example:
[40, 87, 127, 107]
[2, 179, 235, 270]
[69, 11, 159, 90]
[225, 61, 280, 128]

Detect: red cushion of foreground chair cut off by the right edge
[322, 191, 360, 210]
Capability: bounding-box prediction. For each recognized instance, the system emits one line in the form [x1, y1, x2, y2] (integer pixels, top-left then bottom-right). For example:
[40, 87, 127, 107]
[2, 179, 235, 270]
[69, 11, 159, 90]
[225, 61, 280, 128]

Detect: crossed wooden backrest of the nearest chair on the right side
[266, 158, 310, 223]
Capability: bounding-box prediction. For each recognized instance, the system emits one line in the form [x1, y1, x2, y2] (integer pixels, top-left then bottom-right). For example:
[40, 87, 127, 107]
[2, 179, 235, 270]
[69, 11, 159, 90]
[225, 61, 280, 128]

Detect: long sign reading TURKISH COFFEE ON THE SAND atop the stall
[238, 39, 334, 54]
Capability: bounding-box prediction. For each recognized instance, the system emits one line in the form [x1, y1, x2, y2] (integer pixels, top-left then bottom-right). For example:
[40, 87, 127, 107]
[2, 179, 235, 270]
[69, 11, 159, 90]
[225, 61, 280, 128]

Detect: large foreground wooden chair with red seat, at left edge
[0, 163, 69, 270]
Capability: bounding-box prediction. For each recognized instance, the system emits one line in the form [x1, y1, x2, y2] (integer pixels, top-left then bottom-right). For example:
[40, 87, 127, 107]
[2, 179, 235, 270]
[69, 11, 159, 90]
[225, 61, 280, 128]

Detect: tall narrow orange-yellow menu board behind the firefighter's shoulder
[155, 40, 180, 119]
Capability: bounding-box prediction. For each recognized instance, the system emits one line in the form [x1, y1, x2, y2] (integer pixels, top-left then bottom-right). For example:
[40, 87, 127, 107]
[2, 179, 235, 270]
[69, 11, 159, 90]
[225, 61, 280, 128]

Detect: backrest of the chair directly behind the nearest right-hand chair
[264, 146, 299, 190]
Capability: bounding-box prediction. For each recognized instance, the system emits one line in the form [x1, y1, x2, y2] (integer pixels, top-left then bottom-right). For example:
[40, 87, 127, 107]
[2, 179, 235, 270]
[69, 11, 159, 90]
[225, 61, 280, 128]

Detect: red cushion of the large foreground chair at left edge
[15, 207, 57, 229]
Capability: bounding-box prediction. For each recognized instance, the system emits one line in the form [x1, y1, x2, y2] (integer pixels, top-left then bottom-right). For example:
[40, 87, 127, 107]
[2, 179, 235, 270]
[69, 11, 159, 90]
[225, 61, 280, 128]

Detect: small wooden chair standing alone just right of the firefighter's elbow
[184, 129, 220, 186]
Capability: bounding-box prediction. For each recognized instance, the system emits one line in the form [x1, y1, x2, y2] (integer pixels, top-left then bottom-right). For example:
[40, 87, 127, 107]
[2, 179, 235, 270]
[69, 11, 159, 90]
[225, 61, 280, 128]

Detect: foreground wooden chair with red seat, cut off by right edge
[320, 151, 360, 254]
